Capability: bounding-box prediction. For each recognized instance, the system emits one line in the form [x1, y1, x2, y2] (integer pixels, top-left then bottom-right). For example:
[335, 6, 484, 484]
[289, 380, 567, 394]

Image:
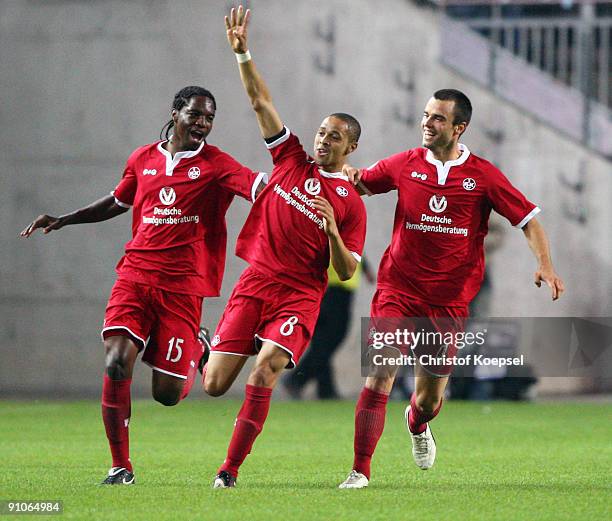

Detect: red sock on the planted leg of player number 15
[102, 374, 132, 472]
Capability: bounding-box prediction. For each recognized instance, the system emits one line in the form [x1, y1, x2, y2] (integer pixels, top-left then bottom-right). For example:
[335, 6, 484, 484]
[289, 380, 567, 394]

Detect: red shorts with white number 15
[102, 279, 203, 379]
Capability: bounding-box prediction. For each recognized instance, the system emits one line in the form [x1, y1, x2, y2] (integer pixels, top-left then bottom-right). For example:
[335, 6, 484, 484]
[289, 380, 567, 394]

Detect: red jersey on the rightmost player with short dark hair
[361, 145, 540, 306]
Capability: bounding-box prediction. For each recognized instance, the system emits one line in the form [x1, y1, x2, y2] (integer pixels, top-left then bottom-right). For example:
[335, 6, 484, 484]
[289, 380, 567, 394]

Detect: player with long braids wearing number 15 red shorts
[21, 86, 265, 484]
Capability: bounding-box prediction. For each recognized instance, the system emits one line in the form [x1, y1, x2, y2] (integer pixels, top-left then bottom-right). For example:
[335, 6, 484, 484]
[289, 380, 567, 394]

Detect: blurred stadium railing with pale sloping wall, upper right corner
[437, 0, 612, 158]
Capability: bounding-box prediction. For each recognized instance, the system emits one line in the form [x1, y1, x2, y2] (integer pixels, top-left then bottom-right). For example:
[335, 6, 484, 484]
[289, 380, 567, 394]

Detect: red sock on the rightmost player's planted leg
[353, 387, 389, 479]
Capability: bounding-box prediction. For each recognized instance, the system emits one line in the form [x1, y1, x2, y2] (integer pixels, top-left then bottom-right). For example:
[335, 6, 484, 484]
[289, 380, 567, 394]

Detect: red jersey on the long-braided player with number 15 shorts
[112, 142, 265, 297]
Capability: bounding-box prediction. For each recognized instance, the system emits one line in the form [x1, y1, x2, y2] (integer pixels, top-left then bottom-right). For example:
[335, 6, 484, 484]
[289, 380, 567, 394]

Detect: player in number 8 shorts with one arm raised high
[204, 6, 366, 488]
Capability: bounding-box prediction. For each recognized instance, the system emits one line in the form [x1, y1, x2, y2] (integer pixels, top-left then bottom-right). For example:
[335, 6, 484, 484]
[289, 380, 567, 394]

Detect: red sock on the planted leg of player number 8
[219, 384, 272, 477]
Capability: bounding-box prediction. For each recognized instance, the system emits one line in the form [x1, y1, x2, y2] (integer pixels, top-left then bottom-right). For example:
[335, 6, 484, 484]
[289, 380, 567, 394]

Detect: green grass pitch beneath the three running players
[0, 399, 612, 521]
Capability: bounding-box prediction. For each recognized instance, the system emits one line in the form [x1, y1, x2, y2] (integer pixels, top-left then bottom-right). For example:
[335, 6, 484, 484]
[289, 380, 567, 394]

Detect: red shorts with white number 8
[211, 267, 321, 368]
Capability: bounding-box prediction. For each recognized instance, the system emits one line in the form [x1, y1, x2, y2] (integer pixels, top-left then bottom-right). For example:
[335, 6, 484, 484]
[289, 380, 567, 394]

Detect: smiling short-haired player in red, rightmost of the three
[340, 89, 564, 488]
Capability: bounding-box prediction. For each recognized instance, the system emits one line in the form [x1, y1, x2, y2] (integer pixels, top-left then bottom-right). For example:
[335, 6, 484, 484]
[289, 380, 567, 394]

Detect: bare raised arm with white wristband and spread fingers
[225, 6, 283, 139]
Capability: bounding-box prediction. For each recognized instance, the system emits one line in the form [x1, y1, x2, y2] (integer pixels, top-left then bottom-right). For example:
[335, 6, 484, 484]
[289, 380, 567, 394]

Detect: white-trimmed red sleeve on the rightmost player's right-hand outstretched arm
[488, 169, 540, 228]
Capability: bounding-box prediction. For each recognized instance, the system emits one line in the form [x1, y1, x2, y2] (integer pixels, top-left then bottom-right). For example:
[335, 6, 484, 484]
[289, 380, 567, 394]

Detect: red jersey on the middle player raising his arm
[236, 128, 366, 294]
